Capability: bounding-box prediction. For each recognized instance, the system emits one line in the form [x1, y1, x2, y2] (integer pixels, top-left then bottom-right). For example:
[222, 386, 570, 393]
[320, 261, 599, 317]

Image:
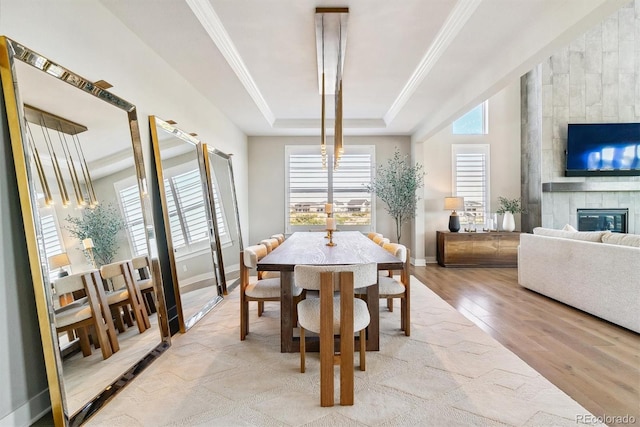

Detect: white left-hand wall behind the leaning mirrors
[0, 0, 248, 425]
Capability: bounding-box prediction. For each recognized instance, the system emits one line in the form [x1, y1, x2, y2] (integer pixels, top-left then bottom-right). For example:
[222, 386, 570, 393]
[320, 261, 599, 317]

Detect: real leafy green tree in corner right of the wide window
[367, 148, 424, 242]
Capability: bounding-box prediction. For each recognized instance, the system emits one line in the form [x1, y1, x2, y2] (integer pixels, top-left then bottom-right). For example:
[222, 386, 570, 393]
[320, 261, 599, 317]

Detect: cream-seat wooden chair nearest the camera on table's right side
[356, 243, 411, 336]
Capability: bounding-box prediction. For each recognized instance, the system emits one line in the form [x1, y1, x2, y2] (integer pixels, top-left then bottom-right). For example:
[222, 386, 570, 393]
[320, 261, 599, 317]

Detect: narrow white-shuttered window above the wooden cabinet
[451, 144, 489, 224]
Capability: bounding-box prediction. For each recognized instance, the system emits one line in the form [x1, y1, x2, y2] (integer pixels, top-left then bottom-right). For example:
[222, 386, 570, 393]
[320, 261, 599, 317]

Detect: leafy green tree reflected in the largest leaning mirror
[65, 203, 126, 267]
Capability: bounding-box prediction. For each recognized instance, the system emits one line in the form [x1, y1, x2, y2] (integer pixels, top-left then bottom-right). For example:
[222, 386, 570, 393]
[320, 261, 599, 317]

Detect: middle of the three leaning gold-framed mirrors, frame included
[149, 116, 225, 332]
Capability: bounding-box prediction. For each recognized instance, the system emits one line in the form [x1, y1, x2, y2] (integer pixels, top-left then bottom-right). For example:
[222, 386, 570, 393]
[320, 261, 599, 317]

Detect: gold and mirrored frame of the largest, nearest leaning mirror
[0, 36, 170, 426]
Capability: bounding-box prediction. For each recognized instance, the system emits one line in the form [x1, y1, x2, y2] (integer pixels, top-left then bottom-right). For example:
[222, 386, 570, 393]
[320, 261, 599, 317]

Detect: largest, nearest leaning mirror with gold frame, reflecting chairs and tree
[0, 37, 169, 425]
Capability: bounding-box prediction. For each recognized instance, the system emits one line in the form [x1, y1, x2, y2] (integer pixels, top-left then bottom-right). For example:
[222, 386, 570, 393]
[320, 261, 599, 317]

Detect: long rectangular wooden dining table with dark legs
[257, 231, 403, 353]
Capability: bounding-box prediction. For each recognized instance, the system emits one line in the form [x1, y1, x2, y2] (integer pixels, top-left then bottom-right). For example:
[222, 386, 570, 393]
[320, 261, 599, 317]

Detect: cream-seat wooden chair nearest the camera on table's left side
[240, 244, 305, 341]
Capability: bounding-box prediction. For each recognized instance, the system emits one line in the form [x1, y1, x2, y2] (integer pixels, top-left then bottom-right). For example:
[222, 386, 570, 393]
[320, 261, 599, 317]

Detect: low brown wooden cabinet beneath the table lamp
[436, 231, 520, 267]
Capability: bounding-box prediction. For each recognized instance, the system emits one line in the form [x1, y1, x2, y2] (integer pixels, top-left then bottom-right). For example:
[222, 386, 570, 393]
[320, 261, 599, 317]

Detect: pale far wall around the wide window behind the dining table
[249, 136, 411, 249]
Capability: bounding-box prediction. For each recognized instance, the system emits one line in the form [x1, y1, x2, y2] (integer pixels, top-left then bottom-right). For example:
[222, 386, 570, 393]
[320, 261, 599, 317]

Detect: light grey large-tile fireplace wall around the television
[523, 0, 640, 234]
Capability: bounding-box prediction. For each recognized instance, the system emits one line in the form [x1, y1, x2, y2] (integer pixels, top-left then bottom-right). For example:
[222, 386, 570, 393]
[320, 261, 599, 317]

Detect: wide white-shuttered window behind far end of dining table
[285, 145, 375, 232]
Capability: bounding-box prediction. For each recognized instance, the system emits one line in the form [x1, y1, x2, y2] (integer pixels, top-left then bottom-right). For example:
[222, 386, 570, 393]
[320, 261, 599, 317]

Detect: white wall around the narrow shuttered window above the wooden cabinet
[414, 80, 520, 263]
